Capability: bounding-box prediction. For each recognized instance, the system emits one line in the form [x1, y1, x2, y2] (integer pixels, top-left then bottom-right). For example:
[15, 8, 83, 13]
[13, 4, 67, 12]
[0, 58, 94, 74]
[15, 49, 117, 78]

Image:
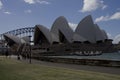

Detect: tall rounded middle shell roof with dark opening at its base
[51, 16, 73, 43]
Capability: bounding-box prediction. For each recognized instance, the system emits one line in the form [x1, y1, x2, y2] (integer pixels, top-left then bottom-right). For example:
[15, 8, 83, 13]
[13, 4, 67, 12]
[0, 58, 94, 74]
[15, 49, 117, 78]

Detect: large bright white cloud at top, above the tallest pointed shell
[80, 0, 107, 12]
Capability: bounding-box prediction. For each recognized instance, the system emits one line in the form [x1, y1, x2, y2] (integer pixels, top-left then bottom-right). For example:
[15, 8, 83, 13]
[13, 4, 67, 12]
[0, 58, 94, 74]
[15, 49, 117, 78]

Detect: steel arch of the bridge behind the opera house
[0, 27, 34, 40]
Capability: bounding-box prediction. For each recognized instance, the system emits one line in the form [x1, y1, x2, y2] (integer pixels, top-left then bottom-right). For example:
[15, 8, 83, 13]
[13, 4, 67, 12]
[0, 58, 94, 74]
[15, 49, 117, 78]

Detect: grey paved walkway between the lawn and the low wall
[12, 56, 120, 75]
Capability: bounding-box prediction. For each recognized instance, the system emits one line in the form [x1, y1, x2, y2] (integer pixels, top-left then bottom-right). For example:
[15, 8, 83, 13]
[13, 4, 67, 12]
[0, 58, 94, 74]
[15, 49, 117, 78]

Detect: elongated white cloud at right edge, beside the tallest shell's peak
[95, 12, 120, 22]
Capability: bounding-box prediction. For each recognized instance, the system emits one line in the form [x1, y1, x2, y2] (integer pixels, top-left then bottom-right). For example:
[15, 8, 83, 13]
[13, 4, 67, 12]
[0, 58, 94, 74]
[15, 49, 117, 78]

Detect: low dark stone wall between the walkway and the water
[34, 56, 120, 67]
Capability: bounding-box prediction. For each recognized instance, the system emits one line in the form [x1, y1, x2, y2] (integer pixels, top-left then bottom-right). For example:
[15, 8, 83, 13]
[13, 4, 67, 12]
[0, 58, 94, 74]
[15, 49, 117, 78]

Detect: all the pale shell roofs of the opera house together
[4, 15, 108, 44]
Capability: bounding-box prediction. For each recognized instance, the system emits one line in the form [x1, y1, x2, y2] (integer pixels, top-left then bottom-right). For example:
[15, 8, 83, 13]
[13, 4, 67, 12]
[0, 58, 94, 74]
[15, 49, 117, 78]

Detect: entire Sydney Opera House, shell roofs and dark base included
[4, 15, 115, 55]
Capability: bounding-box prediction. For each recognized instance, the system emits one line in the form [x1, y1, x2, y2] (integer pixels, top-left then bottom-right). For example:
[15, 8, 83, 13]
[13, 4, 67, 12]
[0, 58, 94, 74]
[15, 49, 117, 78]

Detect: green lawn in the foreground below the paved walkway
[0, 57, 120, 80]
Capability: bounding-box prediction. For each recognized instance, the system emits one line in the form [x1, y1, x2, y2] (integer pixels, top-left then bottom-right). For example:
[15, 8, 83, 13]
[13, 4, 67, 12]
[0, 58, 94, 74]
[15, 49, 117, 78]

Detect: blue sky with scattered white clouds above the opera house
[0, 0, 120, 42]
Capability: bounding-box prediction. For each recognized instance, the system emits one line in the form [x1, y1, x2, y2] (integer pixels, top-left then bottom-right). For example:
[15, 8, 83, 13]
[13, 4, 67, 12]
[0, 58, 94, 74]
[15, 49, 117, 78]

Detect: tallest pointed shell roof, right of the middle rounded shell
[75, 15, 96, 43]
